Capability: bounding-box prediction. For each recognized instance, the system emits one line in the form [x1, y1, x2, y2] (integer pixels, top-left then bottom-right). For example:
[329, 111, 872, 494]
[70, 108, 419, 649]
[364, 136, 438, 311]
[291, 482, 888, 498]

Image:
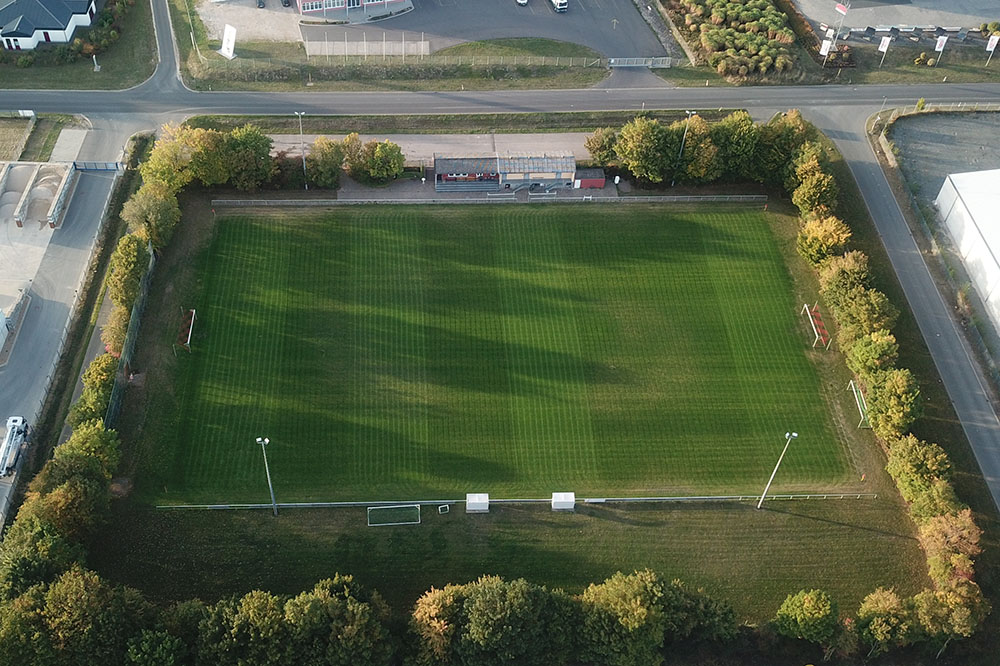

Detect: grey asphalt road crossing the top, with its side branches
[0, 0, 1000, 506]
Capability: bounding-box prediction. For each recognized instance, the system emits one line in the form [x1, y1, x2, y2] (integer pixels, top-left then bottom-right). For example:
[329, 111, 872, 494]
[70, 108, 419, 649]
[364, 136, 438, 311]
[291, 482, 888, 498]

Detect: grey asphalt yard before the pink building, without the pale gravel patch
[302, 0, 667, 58]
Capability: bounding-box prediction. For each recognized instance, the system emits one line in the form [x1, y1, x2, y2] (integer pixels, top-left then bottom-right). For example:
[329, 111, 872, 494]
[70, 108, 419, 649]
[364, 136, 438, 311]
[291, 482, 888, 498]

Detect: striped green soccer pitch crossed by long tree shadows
[160, 205, 850, 502]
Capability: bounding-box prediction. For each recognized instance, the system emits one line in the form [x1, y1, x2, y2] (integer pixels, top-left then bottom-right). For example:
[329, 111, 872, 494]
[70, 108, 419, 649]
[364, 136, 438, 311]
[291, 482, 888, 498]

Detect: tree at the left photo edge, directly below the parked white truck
[0, 515, 84, 602]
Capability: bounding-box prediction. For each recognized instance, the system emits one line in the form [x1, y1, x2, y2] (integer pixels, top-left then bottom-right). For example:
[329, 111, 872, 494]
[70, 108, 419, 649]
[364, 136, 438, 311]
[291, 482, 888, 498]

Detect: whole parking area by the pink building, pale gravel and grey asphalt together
[204, 0, 670, 58]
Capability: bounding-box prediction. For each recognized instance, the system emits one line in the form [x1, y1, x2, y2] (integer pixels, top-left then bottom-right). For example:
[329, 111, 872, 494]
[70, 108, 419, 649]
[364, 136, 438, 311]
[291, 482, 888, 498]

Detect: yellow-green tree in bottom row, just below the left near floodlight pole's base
[198, 590, 288, 666]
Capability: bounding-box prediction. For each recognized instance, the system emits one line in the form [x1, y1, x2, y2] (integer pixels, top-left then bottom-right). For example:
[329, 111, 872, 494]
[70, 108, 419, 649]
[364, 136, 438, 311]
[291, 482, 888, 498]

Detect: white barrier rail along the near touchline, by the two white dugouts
[156, 493, 878, 511]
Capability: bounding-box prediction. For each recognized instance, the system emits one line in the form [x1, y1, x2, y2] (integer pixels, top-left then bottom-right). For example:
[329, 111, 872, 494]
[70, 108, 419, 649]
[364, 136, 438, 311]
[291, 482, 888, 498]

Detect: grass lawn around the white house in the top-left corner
[0, 1, 154, 90]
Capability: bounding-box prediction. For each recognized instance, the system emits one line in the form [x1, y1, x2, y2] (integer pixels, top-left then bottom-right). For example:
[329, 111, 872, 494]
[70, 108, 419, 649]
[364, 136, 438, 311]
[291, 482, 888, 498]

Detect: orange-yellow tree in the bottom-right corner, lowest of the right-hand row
[913, 581, 990, 657]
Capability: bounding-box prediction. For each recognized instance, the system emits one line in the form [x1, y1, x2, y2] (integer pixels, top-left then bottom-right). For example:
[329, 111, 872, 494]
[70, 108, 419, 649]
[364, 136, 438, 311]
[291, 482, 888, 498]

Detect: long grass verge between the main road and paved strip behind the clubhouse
[185, 109, 731, 134]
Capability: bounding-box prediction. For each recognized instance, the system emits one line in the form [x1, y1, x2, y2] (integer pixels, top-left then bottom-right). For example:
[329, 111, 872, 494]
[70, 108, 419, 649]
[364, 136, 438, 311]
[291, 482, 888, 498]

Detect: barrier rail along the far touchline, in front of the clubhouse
[212, 194, 767, 208]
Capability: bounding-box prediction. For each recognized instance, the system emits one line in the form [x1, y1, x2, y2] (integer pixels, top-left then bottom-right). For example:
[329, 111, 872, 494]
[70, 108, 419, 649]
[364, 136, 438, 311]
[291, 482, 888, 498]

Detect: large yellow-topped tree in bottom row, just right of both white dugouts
[580, 569, 665, 666]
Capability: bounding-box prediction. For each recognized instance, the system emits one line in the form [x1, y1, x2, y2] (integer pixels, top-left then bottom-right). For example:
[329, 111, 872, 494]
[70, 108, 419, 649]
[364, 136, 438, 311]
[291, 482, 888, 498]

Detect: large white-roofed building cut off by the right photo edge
[934, 169, 1000, 329]
